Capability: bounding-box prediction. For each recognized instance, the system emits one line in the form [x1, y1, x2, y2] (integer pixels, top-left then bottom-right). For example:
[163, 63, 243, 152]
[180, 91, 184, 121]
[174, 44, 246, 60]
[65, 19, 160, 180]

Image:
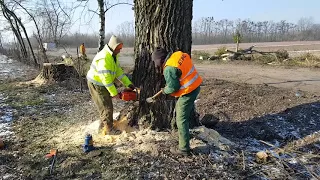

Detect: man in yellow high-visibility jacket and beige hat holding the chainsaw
[87, 36, 135, 135]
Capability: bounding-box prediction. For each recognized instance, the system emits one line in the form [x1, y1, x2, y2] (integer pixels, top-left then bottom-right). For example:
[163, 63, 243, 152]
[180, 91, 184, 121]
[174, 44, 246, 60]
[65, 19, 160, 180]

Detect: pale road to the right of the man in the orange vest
[196, 64, 320, 95]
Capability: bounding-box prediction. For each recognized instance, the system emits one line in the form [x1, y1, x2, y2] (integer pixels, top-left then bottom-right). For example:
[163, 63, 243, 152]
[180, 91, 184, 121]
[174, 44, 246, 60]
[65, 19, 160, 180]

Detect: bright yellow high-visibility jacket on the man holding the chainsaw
[87, 45, 132, 97]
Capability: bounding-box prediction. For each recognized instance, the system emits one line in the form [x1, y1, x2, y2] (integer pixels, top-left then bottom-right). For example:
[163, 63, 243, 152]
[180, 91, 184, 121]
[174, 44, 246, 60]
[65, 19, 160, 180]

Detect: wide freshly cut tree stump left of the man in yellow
[37, 63, 79, 82]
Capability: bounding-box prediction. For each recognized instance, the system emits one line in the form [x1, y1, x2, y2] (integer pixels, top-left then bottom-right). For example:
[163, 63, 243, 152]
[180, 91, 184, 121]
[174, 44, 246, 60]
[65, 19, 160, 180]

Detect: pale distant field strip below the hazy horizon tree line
[48, 41, 320, 65]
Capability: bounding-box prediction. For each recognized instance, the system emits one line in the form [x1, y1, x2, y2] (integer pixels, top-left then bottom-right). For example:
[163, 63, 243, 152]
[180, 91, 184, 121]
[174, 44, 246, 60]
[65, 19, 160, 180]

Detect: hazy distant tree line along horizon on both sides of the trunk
[37, 17, 320, 48]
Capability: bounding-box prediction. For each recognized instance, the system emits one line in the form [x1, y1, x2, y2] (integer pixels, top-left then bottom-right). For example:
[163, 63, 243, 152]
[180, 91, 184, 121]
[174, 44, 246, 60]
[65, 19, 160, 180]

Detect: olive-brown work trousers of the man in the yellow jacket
[88, 81, 113, 129]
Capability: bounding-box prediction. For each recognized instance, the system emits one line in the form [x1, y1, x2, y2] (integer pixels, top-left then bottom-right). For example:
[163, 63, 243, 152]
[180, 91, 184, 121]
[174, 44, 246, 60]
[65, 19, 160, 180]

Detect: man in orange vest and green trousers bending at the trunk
[152, 47, 202, 155]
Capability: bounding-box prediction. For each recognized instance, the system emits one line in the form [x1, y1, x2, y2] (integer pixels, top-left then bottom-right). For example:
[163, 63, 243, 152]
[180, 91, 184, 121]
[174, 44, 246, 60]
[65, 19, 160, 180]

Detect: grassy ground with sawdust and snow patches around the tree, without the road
[0, 67, 320, 179]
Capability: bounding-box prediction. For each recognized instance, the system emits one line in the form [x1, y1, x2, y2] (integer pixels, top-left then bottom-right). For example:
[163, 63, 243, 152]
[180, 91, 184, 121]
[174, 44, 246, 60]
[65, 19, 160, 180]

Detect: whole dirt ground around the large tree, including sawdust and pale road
[0, 51, 320, 179]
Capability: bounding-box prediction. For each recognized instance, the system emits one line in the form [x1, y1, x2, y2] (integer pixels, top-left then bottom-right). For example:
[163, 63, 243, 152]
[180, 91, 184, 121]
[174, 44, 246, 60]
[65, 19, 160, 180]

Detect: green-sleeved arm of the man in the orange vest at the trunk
[163, 66, 182, 94]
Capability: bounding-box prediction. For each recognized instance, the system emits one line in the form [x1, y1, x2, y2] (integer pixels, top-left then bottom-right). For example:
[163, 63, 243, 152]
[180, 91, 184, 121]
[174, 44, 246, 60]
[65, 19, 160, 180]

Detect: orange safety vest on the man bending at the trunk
[164, 51, 202, 97]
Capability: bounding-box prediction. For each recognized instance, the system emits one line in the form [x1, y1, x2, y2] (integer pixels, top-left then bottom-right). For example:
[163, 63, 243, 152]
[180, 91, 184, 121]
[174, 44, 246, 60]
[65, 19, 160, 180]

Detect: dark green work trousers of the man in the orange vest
[176, 86, 200, 151]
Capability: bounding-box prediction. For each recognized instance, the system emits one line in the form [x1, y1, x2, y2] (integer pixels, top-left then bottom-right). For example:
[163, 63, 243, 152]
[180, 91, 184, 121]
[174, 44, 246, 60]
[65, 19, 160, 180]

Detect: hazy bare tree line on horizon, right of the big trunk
[192, 17, 320, 44]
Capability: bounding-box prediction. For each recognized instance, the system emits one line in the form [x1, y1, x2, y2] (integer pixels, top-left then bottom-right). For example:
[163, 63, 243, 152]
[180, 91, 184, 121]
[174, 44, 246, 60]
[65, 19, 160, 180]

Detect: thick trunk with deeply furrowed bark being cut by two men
[131, 0, 193, 129]
